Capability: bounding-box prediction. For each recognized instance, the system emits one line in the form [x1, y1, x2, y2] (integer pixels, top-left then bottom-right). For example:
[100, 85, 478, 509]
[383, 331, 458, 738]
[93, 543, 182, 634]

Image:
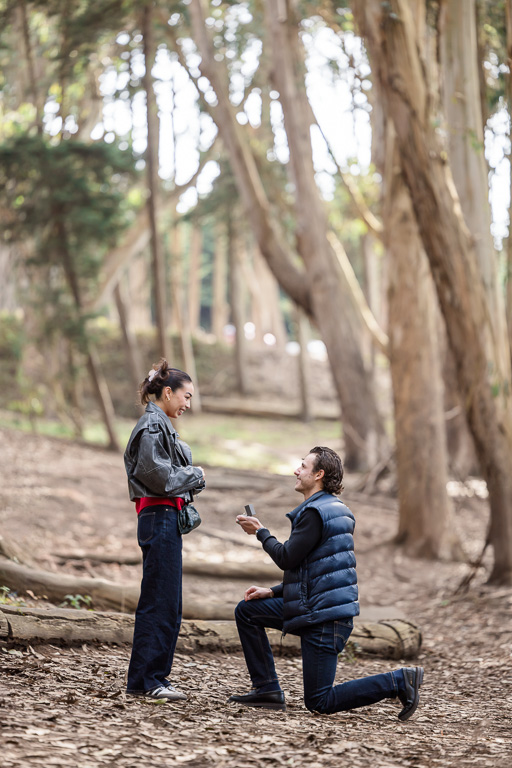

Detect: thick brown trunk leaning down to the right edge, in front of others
[354, 0, 512, 584]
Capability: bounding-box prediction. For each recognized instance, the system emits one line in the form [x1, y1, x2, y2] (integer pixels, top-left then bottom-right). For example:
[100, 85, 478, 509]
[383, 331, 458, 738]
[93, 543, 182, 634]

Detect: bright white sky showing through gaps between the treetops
[80, 15, 510, 247]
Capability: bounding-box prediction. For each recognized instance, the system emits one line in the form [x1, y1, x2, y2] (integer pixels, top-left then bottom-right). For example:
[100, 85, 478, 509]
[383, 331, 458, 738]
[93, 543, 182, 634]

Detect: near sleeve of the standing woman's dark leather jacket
[133, 430, 204, 496]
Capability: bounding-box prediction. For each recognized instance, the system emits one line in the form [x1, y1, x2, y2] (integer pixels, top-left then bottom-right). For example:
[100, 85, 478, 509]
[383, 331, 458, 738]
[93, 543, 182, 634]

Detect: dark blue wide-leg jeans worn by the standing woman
[126, 505, 182, 694]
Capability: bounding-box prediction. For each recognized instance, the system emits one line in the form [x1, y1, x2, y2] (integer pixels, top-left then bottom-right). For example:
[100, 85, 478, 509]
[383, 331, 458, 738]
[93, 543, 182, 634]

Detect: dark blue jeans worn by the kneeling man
[235, 597, 404, 714]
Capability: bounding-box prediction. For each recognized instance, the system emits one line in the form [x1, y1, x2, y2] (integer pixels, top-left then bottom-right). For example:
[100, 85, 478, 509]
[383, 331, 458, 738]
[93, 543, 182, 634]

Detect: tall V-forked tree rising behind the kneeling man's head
[189, 0, 385, 470]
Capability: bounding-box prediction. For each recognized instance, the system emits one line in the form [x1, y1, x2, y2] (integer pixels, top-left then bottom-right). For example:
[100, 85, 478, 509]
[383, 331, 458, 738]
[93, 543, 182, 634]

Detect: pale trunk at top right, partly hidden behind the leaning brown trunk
[439, 0, 510, 476]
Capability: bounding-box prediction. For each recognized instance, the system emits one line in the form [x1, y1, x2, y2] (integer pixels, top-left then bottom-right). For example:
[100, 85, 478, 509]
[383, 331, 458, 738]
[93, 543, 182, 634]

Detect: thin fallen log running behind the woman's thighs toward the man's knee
[55, 550, 282, 583]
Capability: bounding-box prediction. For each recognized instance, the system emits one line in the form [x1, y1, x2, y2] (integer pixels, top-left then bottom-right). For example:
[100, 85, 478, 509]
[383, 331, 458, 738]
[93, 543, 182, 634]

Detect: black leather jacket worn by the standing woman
[124, 402, 205, 501]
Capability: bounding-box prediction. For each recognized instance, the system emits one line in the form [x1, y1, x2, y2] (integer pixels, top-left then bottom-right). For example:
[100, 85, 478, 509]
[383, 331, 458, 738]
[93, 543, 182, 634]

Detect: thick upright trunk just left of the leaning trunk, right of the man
[385, 136, 462, 559]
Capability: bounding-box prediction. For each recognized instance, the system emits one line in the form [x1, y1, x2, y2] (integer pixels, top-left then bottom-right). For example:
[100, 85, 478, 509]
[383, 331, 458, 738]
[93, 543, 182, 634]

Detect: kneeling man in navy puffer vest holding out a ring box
[229, 447, 423, 721]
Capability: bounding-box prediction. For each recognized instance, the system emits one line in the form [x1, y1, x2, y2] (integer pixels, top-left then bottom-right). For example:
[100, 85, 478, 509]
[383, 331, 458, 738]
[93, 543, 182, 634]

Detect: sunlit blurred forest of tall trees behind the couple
[0, 0, 512, 583]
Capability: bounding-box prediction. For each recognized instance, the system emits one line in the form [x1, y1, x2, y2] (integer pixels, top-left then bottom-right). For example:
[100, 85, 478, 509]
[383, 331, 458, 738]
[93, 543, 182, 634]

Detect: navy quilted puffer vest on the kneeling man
[283, 491, 359, 632]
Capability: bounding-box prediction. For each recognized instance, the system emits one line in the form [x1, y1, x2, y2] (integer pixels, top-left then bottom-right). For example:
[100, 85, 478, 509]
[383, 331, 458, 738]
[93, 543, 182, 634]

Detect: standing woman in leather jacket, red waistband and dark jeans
[124, 359, 205, 701]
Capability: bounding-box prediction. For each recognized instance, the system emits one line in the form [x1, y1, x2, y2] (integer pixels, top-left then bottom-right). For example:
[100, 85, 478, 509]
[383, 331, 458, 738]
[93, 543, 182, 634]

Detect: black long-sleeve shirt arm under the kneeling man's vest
[256, 507, 322, 597]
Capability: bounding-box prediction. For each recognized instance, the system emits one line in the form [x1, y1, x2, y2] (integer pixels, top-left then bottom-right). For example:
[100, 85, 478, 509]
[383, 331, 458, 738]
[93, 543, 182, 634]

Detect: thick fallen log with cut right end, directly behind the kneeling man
[0, 605, 421, 659]
